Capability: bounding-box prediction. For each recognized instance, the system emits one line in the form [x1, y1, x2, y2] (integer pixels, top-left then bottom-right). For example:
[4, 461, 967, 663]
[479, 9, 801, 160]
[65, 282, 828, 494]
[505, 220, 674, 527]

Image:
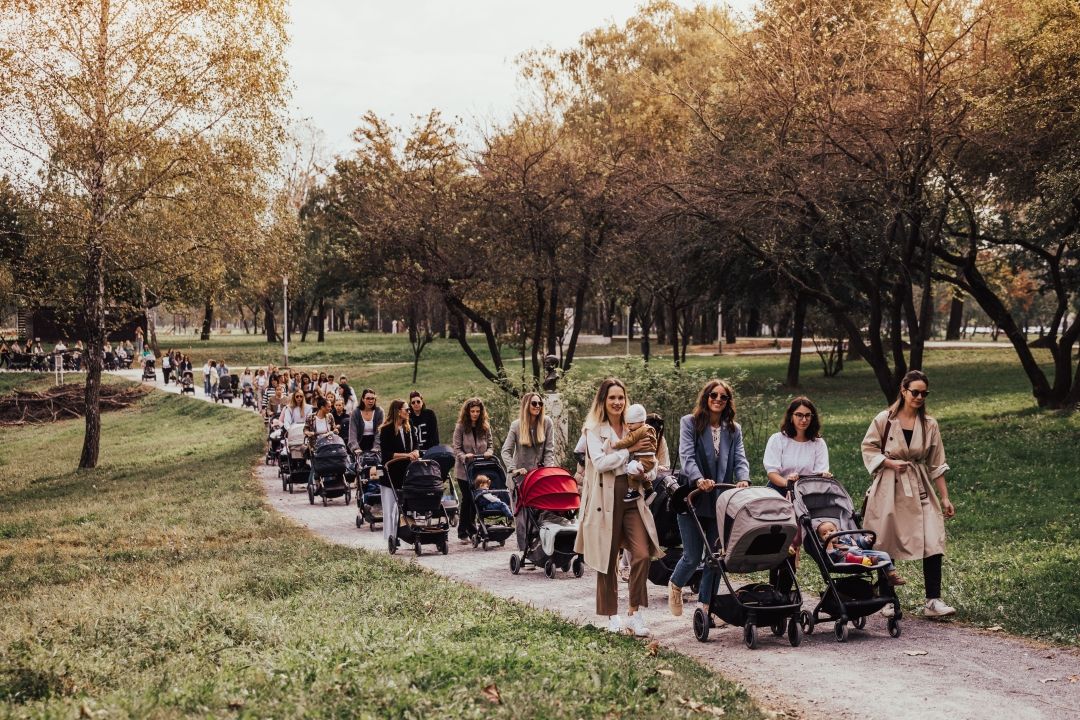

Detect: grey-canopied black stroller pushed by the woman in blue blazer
[687, 483, 802, 650]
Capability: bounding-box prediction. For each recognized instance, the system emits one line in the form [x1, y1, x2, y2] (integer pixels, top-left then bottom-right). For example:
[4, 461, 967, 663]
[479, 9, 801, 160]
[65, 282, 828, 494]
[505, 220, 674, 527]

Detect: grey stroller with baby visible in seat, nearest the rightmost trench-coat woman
[794, 476, 902, 642]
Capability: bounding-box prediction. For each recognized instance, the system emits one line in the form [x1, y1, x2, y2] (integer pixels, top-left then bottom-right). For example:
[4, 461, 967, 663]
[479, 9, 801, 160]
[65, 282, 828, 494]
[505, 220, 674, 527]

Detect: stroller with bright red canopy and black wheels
[510, 467, 585, 579]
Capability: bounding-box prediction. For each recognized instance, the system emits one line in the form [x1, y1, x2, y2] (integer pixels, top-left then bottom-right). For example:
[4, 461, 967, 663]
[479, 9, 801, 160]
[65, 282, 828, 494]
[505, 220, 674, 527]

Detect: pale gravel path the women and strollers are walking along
[122, 373, 1080, 720]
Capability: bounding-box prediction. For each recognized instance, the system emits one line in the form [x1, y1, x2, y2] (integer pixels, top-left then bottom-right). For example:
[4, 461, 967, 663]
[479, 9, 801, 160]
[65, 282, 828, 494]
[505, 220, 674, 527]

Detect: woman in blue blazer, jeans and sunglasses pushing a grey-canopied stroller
[667, 379, 750, 623]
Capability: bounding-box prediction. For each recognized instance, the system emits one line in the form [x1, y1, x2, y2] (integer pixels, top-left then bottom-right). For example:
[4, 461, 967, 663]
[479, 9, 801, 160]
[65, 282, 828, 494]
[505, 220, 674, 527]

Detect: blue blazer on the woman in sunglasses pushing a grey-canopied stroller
[678, 415, 750, 517]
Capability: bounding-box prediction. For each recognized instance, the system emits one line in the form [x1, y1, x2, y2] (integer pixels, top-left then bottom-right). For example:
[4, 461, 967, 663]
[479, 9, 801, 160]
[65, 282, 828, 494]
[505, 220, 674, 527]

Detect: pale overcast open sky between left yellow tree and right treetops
[288, 0, 751, 152]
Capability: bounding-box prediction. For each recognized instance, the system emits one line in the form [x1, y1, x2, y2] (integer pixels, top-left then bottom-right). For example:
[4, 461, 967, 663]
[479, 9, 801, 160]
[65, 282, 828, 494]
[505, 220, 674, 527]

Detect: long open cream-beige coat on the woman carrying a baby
[573, 422, 661, 572]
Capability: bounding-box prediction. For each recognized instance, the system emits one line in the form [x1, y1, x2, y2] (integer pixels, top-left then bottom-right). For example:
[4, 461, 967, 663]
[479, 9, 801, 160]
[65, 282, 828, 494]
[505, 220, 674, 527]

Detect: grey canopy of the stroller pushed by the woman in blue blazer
[716, 488, 798, 572]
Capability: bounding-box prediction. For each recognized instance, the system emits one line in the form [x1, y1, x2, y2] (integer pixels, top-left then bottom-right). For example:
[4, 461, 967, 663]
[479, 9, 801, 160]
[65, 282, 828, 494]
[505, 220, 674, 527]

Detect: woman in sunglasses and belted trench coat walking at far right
[862, 370, 956, 617]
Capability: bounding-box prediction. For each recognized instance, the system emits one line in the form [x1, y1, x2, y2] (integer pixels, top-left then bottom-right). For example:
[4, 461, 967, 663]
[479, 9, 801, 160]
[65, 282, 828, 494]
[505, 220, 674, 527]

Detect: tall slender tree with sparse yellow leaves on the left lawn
[0, 0, 286, 467]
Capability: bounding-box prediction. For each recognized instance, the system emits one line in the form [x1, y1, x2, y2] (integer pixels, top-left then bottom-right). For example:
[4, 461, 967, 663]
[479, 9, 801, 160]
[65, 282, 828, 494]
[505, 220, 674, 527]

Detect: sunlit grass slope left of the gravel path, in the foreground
[0, 386, 760, 718]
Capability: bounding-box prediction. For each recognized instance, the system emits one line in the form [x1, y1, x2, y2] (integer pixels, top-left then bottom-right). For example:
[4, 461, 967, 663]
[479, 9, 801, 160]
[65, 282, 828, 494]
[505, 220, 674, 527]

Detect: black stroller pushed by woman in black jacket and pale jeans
[387, 460, 450, 555]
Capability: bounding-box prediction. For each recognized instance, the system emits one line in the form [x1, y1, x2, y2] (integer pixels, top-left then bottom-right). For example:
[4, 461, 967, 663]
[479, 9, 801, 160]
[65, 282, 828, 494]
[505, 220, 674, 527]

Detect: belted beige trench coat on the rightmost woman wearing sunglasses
[863, 410, 949, 560]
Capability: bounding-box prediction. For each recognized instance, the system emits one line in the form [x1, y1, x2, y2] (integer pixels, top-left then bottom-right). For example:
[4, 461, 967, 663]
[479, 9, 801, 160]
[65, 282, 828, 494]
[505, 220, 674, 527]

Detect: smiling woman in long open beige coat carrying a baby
[575, 378, 660, 637]
